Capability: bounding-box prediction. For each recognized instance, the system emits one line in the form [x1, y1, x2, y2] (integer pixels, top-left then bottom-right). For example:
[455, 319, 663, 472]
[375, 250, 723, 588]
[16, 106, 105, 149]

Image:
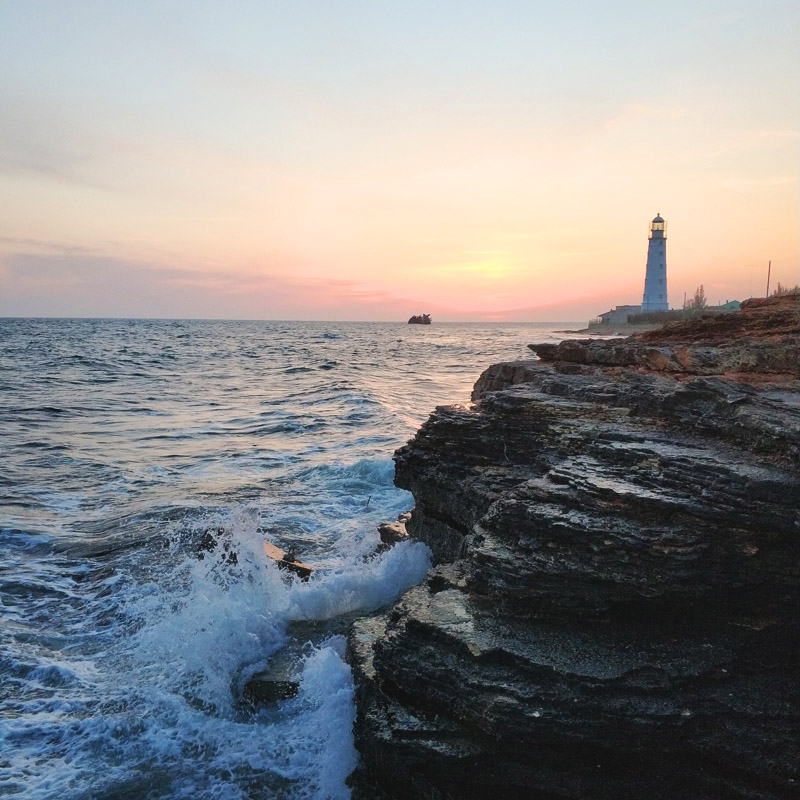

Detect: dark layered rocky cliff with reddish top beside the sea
[349, 297, 800, 800]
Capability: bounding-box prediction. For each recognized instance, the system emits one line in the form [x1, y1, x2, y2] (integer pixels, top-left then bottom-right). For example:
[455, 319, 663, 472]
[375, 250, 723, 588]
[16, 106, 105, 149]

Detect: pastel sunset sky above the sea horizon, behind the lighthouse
[0, 0, 800, 321]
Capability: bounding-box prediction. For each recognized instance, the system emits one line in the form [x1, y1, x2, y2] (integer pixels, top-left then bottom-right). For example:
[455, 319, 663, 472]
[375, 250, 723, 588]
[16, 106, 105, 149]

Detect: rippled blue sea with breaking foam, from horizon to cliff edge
[0, 318, 575, 800]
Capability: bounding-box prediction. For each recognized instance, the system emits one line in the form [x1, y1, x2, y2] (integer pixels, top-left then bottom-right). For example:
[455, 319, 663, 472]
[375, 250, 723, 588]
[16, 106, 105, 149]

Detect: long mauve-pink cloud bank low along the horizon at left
[0, 252, 432, 319]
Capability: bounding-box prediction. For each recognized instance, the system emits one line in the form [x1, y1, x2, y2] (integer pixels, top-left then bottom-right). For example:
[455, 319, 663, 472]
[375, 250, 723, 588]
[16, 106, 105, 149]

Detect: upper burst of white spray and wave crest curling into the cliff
[128, 515, 430, 713]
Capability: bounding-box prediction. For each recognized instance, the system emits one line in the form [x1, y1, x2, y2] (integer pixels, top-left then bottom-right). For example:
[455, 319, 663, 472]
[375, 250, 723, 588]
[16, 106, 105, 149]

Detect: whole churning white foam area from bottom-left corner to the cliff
[0, 510, 429, 800]
